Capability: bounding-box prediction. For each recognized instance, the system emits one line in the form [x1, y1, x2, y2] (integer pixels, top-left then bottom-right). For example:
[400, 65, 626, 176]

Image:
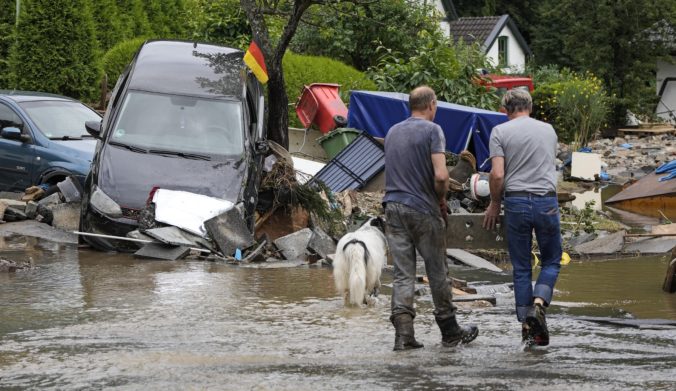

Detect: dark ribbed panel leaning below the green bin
[313, 133, 385, 193]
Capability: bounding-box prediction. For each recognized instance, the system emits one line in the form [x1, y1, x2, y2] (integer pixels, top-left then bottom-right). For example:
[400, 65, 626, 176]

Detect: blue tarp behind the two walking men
[347, 91, 507, 171]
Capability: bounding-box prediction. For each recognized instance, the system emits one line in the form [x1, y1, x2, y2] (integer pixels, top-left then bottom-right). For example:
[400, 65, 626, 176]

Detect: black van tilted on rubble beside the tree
[80, 41, 267, 250]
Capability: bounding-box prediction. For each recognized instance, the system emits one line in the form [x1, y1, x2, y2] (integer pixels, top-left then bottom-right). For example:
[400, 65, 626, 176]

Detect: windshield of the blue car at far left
[19, 100, 101, 139]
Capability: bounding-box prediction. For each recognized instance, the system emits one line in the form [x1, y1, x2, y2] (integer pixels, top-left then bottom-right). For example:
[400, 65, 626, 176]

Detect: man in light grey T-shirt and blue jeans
[484, 90, 562, 346]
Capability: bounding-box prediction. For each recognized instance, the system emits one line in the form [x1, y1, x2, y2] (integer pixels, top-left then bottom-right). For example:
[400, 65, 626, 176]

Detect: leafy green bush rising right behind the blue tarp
[368, 31, 499, 110]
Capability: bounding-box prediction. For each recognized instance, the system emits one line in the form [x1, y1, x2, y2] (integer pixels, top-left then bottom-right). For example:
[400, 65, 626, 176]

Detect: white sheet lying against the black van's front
[153, 189, 234, 237]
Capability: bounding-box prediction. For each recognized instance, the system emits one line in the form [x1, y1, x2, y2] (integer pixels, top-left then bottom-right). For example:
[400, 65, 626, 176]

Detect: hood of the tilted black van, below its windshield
[98, 145, 248, 209]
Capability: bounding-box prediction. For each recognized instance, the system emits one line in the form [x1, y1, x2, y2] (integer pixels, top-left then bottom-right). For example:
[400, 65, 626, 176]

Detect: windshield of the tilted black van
[110, 91, 244, 156]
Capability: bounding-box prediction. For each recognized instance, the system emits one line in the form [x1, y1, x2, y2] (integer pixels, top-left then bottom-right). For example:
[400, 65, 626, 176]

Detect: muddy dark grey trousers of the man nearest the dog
[385, 202, 455, 320]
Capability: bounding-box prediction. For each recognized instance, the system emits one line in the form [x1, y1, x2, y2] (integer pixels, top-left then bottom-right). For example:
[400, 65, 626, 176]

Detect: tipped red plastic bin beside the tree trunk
[296, 83, 347, 133]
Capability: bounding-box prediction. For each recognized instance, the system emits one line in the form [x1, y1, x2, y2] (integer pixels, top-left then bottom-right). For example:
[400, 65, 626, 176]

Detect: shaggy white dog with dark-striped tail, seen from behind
[333, 217, 387, 306]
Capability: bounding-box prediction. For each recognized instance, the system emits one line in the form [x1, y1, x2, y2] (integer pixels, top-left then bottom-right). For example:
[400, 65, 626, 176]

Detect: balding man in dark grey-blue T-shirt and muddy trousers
[383, 86, 479, 350]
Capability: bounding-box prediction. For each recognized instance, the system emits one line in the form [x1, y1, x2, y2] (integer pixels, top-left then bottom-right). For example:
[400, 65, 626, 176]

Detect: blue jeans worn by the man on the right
[505, 195, 562, 322]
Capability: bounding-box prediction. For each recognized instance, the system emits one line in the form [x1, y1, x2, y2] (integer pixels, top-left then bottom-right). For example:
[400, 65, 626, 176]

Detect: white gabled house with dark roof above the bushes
[436, 9, 532, 73]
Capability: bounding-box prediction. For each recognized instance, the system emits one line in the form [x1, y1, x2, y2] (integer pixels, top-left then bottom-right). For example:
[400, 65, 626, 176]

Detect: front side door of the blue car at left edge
[0, 102, 35, 191]
